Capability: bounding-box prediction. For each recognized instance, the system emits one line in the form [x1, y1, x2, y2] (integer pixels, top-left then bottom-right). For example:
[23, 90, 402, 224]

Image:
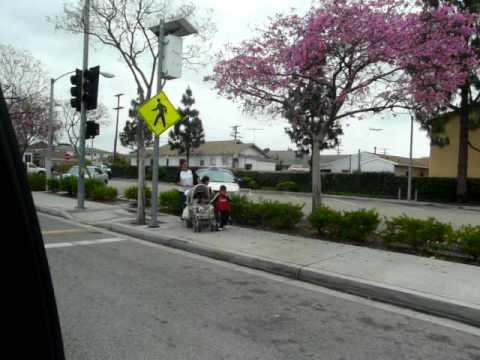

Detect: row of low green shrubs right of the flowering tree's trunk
[308, 207, 480, 260]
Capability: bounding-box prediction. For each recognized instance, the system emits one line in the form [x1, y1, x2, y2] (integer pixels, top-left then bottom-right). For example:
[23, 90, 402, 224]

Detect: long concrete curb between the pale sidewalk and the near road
[96, 223, 480, 327]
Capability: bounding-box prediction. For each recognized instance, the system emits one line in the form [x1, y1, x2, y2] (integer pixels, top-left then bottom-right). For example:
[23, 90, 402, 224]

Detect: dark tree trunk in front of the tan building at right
[457, 84, 469, 202]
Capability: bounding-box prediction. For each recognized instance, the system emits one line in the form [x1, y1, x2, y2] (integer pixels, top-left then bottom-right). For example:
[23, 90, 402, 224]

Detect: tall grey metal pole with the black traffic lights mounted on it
[77, 0, 90, 209]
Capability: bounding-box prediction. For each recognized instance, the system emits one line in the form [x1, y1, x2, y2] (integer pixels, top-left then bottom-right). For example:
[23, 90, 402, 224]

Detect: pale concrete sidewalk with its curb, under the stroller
[33, 193, 480, 326]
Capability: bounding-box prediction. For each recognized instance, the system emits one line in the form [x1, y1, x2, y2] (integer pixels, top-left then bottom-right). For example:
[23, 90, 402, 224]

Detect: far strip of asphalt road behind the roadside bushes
[110, 179, 480, 227]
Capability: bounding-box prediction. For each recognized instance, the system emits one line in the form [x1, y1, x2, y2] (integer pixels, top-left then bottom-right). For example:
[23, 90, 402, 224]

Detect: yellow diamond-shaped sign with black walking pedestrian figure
[138, 91, 181, 135]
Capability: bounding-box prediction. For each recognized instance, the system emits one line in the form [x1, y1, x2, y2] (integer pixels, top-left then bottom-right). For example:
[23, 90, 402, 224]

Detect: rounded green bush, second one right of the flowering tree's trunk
[340, 209, 380, 241]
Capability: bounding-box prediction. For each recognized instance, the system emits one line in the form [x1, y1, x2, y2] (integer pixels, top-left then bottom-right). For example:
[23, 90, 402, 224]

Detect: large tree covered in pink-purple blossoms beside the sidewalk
[207, 0, 473, 210]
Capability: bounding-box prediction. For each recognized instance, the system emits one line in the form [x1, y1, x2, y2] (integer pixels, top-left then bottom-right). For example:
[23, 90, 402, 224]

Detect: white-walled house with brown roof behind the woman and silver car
[130, 140, 275, 171]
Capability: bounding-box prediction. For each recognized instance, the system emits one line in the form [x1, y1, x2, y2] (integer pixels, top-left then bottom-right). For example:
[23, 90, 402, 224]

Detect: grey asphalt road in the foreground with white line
[40, 215, 480, 360]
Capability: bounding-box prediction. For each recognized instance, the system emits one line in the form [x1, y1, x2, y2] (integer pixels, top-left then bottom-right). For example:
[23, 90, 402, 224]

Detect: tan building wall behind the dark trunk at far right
[429, 117, 480, 178]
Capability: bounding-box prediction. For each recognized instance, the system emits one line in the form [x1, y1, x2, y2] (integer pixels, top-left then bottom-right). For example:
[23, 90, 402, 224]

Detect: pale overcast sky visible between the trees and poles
[0, 0, 430, 157]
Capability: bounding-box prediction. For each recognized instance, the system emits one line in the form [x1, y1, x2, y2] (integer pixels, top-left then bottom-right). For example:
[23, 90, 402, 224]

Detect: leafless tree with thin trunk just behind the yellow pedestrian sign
[50, 0, 216, 224]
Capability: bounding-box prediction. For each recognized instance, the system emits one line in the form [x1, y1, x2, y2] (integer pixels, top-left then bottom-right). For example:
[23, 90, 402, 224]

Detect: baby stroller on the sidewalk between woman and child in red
[183, 184, 218, 232]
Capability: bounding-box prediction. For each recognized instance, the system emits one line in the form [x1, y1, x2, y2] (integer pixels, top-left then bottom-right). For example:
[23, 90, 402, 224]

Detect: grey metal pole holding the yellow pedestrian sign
[150, 19, 164, 227]
